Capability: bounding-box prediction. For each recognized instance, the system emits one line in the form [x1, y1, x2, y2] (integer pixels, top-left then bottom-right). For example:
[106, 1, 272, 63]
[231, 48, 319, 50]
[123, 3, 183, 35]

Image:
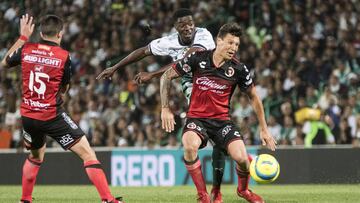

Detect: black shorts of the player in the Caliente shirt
[183, 118, 243, 152]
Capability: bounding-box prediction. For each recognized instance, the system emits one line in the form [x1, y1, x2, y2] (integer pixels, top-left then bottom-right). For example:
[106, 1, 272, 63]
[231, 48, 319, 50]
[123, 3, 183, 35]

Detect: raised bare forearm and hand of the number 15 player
[1, 14, 35, 68]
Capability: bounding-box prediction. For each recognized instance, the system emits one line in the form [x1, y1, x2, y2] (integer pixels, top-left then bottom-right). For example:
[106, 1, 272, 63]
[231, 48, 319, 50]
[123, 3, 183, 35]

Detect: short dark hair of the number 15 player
[40, 15, 64, 36]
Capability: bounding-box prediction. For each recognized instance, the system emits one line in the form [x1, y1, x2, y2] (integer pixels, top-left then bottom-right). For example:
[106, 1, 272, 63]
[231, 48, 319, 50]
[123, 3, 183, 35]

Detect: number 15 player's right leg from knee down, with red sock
[70, 136, 122, 203]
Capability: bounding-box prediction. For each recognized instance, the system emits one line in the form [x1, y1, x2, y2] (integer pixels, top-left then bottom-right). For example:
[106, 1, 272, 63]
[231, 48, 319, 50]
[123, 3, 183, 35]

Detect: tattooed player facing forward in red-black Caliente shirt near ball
[160, 23, 276, 203]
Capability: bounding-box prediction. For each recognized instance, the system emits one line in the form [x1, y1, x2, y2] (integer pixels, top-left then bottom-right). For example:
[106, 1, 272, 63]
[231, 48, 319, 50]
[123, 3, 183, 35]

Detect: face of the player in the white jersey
[175, 16, 195, 43]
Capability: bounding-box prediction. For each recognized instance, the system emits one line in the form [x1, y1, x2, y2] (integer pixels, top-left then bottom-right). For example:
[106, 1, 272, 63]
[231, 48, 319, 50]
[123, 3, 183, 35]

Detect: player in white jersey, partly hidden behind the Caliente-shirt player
[96, 8, 225, 203]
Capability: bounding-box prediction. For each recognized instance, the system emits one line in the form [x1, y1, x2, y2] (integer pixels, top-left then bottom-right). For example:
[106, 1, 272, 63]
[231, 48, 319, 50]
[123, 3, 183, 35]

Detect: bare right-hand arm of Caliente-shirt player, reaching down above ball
[247, 86, 277, 151]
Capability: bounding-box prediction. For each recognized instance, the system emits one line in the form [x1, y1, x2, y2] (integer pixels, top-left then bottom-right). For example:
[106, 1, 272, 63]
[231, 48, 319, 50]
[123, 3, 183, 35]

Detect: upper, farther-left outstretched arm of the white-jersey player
[96, 46, 151, 80]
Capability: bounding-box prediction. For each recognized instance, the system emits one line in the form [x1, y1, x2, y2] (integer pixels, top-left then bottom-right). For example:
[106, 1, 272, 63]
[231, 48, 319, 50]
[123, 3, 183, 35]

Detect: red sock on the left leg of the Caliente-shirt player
[184, 157, 207, 193]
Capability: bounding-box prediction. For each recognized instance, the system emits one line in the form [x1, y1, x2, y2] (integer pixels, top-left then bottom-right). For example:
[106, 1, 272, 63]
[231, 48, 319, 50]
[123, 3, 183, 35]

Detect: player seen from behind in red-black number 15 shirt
[1, 14, 122, 203]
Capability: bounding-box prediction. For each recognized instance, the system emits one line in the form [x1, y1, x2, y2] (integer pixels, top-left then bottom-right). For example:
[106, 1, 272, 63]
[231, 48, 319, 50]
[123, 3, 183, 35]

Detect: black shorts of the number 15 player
[21, 112, 85, 150]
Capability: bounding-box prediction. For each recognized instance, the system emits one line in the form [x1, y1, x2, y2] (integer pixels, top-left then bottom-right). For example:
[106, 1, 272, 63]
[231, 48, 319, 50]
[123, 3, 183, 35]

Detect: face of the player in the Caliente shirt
[216, 34, 240, 60]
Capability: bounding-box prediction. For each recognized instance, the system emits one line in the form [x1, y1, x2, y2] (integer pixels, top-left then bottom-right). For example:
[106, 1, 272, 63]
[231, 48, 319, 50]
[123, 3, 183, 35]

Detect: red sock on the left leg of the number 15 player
[21, 158, 42, 202]
